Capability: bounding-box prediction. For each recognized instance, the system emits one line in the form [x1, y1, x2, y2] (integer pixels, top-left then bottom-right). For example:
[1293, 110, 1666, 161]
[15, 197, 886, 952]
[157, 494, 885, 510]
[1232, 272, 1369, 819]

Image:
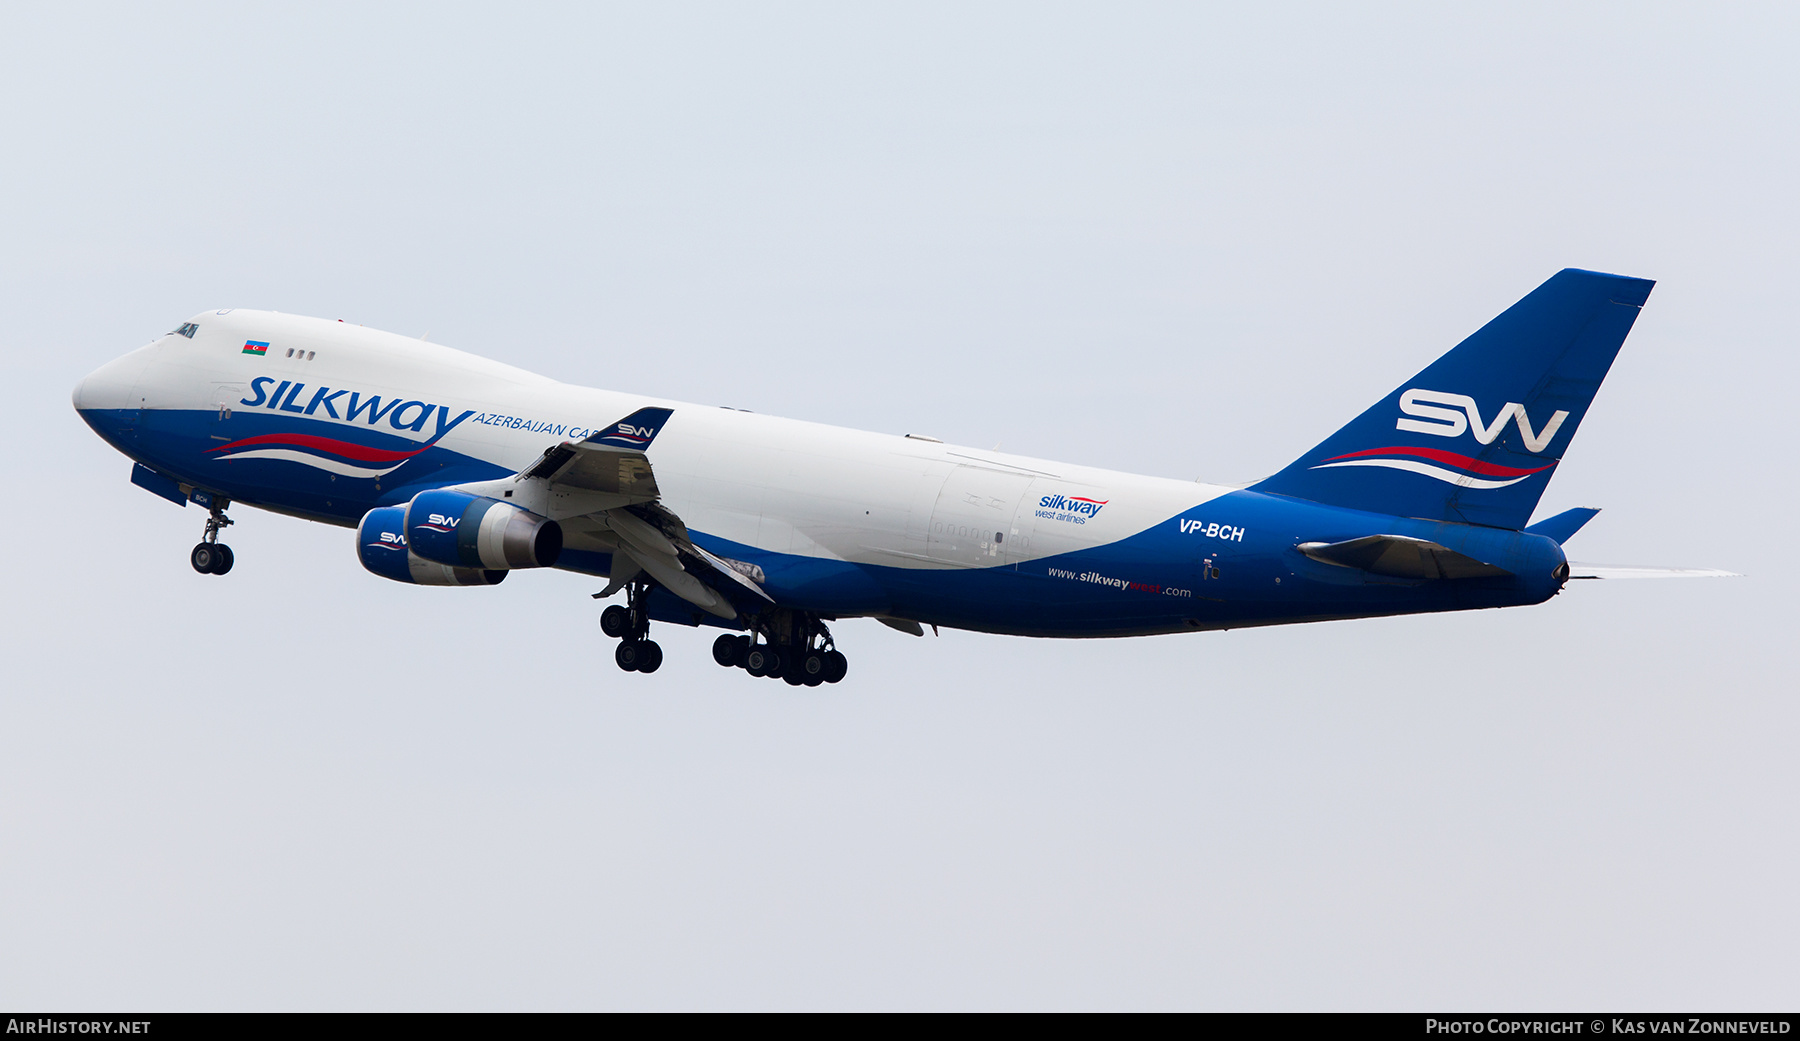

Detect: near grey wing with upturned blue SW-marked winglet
[444, 409, 774, 618]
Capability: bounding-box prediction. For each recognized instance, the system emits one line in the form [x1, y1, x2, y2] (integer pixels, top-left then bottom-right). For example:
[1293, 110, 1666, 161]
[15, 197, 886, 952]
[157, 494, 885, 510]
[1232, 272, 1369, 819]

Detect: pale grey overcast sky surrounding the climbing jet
[0, 4, 1800, 1010]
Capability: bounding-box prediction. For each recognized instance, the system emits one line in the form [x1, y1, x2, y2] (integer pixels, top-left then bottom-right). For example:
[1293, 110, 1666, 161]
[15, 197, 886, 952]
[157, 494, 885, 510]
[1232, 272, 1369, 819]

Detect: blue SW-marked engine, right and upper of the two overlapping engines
[405, 490, 562, 571]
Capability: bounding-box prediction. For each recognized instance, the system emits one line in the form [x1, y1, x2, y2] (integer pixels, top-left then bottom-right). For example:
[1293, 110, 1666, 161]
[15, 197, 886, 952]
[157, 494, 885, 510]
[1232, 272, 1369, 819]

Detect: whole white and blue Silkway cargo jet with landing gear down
[74, 270, 1724, 684]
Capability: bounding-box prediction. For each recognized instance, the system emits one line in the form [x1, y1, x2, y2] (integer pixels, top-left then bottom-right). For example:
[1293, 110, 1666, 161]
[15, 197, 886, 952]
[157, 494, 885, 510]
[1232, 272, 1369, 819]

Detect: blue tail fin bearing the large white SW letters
[1253, 268, 1656, 530]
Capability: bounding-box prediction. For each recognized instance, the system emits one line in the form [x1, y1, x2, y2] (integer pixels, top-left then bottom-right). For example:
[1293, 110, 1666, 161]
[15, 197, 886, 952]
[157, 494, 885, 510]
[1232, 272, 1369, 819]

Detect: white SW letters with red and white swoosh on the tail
[1312, 387, 1570, 488]
